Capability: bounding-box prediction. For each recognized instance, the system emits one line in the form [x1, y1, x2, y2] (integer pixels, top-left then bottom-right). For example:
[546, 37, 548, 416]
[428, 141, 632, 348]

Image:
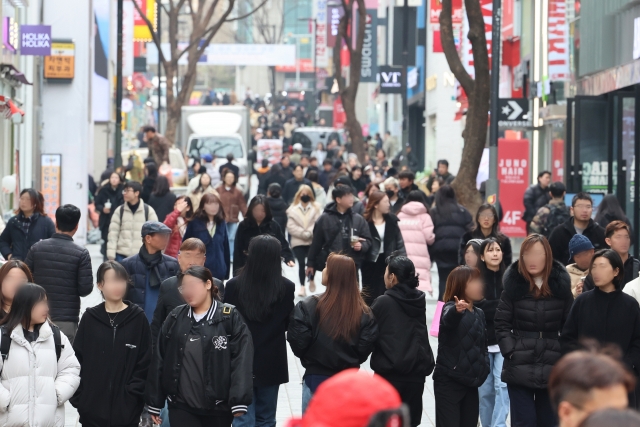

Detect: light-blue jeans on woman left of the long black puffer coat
[478, 353, 509, 427]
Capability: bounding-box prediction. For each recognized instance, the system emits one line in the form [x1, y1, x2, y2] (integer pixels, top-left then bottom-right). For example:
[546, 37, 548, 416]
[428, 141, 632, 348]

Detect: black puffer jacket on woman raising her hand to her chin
[433, 301, 489, 387]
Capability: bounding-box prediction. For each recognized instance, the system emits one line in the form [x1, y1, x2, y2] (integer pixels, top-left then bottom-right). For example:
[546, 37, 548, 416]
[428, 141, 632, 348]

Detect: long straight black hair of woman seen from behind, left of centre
[236, 234, 286, 322]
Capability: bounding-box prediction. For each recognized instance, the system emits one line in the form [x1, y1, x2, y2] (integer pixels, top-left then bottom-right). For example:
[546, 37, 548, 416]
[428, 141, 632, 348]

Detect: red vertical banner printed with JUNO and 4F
[500, 138, 529, 237]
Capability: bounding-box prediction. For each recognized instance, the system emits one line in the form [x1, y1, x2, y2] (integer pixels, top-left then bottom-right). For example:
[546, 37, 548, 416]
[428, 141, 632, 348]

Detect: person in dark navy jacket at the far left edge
[0, 188, 56, 261]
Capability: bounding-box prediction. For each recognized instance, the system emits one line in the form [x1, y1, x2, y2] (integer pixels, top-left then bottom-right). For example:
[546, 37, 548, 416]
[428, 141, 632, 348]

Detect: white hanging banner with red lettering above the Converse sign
[549, 0, 571, 81]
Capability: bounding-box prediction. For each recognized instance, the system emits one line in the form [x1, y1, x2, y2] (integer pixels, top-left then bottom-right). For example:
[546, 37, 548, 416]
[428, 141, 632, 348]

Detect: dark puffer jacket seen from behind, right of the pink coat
[429, 205, 473, 267]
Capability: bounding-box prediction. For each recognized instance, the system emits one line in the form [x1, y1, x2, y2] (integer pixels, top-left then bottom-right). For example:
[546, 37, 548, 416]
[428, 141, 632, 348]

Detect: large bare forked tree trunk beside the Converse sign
[440, 0, 491, 210]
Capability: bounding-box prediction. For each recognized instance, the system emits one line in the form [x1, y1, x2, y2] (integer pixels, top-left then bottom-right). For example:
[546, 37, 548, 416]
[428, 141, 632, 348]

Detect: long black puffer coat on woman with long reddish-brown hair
[494, 261, 573, 389]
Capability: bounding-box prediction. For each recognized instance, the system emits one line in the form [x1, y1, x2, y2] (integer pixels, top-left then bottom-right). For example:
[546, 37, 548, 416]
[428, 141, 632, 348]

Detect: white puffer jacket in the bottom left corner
[0, 322, 80, 427]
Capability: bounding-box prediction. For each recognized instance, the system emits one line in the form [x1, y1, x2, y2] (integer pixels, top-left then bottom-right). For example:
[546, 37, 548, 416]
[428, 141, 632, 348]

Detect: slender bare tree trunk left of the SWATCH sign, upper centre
[333, 0, 367, 162]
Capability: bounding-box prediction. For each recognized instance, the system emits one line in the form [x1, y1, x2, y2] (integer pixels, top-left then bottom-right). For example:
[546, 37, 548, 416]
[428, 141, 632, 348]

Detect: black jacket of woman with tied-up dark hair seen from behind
[371, 283, 435, 383]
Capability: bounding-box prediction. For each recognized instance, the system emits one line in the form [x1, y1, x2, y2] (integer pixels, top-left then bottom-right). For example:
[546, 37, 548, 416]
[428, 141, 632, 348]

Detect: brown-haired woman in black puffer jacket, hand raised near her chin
[433, 266, 490, 427]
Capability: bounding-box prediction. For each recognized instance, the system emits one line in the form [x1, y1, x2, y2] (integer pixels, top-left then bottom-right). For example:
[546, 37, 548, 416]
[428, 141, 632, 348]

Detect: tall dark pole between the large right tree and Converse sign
[483, 0, 502, 209]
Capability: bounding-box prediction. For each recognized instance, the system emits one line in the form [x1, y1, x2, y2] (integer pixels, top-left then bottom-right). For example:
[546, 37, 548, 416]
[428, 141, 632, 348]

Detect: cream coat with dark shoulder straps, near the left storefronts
[107, 199, 158, 259]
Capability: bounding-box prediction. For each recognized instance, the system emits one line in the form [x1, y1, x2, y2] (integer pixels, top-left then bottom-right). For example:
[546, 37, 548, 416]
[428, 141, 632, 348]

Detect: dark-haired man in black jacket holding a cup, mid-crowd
[307, 185, 371, 275]
